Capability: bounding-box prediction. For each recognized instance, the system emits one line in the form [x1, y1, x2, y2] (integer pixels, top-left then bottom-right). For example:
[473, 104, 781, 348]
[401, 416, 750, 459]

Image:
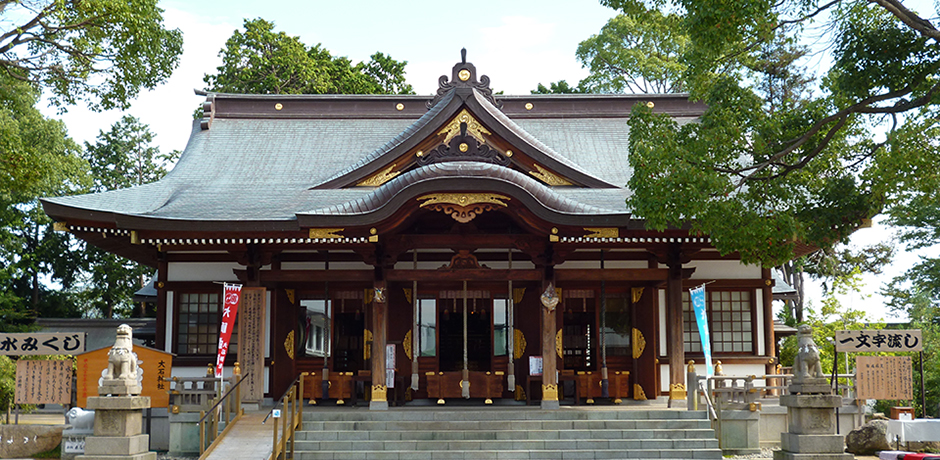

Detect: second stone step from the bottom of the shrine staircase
[294, 439, 718, 452]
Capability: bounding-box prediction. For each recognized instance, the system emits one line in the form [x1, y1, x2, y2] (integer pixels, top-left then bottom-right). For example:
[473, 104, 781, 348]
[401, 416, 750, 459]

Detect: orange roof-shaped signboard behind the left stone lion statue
[75, 345, 173, 407]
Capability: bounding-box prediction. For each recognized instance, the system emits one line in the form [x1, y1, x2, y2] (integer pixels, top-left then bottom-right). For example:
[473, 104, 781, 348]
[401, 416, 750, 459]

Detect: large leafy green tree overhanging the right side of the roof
[603, 0, 940, 266]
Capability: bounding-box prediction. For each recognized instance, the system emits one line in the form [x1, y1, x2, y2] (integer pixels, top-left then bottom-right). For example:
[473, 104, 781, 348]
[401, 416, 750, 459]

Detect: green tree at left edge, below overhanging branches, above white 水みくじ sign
[0, 75, 88, 330]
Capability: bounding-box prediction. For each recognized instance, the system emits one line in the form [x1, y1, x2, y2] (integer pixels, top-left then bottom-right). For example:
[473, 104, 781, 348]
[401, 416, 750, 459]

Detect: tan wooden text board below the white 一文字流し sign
[855, 356, 914, 399]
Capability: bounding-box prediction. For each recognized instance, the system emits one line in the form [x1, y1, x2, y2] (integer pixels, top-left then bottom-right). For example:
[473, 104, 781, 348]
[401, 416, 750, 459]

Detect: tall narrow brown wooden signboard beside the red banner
[238, 287, 267, 402]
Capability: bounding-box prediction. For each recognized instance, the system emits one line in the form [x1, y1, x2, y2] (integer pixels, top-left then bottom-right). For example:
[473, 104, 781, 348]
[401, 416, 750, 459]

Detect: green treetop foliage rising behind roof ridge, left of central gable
[204, 18, 414, 94]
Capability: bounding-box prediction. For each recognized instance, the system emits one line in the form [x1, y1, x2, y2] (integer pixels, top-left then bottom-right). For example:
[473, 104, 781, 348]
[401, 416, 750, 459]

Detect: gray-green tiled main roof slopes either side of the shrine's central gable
[43, 90, 692, 226]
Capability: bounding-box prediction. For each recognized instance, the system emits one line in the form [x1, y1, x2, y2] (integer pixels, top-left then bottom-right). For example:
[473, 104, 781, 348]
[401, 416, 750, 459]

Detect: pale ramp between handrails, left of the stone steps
[200, 412, 270, 460]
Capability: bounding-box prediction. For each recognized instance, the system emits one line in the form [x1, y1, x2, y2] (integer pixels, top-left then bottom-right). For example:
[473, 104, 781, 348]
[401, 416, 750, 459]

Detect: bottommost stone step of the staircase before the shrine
[295, 449, 722, 460]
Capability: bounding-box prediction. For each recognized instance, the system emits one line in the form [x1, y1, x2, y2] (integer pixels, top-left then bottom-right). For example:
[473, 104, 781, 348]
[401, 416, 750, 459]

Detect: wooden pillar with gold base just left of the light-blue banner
[666, 244, 686, 404]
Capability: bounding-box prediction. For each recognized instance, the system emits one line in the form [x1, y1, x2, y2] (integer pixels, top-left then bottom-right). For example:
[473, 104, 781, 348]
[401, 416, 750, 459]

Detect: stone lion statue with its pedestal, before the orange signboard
[76, 324, 157, 460]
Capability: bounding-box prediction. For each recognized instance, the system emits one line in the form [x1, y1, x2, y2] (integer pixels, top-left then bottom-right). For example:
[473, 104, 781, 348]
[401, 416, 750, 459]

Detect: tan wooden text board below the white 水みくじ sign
[13, 359, 72, 404]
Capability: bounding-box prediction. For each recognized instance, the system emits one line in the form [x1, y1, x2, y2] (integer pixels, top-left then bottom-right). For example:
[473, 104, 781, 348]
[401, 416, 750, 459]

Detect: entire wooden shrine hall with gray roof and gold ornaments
[42, 53, 776, 409]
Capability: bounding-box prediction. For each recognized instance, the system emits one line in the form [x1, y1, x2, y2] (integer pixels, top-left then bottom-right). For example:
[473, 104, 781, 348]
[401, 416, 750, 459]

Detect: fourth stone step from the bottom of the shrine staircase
[303, 420, 711, 431]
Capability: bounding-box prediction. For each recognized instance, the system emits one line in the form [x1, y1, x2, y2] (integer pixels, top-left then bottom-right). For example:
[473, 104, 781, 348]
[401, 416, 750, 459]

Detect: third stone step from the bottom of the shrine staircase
[296, 428, 715, 441]
